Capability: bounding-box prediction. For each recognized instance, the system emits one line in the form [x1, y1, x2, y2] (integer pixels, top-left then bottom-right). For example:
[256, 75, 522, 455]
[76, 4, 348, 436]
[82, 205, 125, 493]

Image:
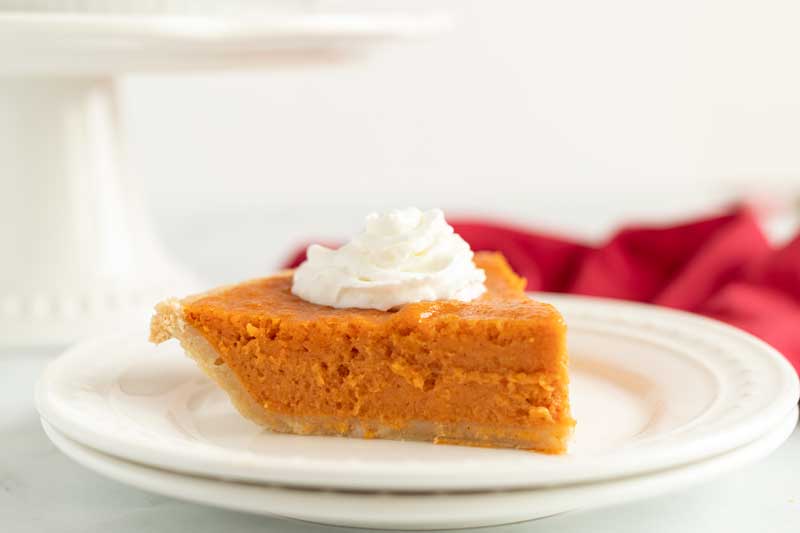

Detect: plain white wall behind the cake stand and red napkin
[128, 0, 800, 229]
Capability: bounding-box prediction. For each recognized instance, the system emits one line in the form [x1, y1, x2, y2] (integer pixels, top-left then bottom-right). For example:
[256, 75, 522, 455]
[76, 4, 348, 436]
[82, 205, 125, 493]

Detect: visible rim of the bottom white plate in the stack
[41, 406, 798, 529]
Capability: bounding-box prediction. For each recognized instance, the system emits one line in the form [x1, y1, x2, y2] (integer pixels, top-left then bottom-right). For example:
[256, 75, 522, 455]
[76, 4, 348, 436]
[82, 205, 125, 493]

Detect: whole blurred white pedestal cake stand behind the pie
[0, 7, 447, 346]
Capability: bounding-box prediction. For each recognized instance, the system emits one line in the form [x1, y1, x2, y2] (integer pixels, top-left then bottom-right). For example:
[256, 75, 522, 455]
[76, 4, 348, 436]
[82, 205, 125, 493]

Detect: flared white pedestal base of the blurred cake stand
[0, 77, 193, 346]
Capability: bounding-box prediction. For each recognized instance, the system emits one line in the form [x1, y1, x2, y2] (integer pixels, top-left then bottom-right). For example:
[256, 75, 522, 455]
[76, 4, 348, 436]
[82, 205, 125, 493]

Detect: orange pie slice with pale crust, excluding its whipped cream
[150, 252, 575, 453]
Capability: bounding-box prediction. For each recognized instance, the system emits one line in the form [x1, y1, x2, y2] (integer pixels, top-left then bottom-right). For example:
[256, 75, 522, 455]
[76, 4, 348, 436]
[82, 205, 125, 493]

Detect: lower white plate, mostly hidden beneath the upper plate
[43, 407, 797, 529]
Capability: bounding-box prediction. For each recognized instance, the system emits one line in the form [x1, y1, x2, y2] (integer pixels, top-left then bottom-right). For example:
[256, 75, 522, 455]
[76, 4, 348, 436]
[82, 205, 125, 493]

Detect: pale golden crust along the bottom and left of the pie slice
[150, 299, 572, 453]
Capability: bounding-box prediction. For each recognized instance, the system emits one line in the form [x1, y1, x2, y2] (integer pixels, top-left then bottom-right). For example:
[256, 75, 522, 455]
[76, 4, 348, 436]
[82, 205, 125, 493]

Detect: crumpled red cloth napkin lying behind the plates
[286, 208, 800, 372]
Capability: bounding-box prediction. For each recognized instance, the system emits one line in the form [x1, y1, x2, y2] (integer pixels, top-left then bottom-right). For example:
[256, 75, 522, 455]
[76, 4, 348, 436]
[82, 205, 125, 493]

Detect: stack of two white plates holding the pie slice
[37, 295, 799, 529]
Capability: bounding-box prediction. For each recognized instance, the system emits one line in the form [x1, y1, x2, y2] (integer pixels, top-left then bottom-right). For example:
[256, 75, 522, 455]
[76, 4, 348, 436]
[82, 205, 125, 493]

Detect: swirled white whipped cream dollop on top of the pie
[292, 207, 486, 311]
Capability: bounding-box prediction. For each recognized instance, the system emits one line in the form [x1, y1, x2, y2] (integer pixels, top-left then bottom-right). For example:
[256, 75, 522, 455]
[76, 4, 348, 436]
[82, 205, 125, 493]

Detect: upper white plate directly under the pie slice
[37, 295, 798, 491]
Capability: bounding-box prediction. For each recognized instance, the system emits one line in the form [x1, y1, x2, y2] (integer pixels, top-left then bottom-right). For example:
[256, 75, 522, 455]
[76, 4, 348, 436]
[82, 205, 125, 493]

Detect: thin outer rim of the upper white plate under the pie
[36, 293, 800, 491]
